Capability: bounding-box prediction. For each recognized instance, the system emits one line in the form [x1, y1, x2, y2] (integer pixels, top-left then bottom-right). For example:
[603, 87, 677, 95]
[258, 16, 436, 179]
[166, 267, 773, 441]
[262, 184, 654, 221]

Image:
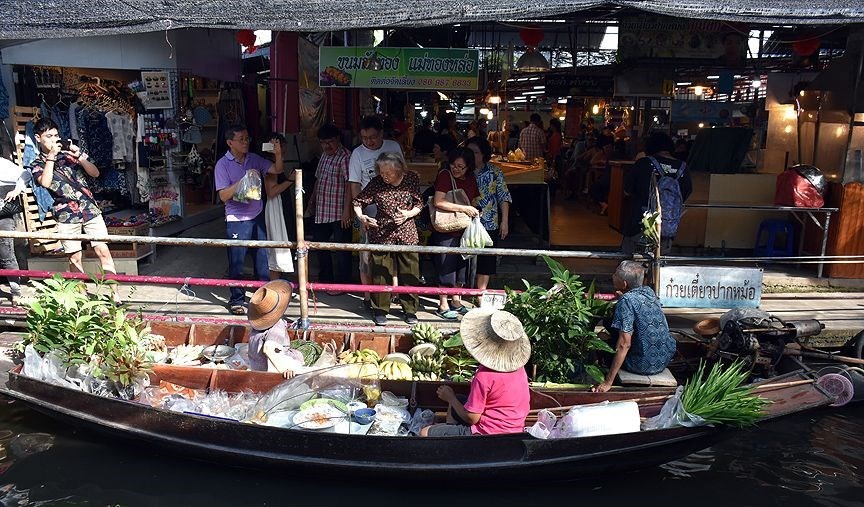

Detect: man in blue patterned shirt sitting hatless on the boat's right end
[593, 261, 675, 393]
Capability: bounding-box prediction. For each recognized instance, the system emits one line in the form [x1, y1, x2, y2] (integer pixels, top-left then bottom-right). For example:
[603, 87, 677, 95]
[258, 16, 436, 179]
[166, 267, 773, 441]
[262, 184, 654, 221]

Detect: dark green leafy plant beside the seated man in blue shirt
[504, 256, 613, 383]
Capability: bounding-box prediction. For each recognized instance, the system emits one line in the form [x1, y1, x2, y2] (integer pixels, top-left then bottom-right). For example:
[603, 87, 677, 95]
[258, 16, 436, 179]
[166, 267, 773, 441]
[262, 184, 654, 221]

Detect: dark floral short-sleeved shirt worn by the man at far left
[33, 153, 102, 224]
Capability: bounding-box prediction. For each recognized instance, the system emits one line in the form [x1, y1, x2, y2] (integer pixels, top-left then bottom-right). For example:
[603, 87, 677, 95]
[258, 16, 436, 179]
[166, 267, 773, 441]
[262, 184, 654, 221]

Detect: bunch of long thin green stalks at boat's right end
[681, 361, 770, 427]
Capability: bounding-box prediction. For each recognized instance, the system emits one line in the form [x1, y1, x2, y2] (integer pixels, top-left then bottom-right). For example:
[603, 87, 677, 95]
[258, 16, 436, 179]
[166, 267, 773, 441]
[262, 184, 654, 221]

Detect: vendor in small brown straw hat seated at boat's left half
[247, 280, 294, 378]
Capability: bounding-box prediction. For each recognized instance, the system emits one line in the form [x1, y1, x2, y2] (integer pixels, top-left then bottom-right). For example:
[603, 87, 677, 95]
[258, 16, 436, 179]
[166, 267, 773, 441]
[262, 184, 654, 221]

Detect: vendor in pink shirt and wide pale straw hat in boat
[420, 309, 531, 437]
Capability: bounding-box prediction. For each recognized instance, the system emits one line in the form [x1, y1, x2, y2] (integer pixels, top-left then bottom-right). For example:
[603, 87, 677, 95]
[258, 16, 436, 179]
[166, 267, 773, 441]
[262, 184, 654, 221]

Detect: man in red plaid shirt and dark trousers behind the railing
[306, 123, 353, 295]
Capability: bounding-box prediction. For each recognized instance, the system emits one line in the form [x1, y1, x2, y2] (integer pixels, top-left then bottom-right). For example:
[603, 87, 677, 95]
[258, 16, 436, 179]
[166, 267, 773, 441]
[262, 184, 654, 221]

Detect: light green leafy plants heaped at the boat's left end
[20, 275, 150, 387]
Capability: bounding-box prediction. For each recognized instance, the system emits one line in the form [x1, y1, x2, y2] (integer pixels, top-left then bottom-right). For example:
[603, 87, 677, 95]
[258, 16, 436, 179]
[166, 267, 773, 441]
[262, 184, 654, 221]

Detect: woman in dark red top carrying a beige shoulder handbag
[429, 148, 480, 320]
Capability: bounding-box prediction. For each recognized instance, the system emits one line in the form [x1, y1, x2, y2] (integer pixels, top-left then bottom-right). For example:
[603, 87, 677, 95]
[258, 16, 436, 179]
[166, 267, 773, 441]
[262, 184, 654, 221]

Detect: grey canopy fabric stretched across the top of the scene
[0, 0, 864, 39]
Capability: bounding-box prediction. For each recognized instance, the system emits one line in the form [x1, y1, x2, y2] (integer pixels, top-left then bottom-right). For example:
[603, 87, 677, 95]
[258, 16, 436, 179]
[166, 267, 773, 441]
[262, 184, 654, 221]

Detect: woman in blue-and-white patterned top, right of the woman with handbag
[465, 137, 513, 290]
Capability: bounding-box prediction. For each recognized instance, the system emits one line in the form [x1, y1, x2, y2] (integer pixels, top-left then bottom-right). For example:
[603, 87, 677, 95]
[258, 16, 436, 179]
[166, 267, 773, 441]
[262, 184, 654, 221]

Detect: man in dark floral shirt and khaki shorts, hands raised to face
[32, 118, 120, 303]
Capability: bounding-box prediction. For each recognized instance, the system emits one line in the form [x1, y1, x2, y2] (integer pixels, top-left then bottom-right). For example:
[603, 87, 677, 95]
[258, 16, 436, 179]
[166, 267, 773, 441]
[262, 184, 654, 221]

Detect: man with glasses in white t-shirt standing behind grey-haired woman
[348, 116, 402, 308]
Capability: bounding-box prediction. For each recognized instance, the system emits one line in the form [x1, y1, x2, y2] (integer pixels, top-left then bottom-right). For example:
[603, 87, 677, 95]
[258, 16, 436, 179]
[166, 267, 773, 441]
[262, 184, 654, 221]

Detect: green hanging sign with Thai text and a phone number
[318, 46, 479, 91]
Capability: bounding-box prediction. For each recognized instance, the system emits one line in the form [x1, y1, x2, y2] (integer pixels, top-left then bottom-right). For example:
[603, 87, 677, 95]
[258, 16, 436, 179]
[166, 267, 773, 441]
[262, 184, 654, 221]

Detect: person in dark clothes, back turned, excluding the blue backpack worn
[621, 132, 693, 255]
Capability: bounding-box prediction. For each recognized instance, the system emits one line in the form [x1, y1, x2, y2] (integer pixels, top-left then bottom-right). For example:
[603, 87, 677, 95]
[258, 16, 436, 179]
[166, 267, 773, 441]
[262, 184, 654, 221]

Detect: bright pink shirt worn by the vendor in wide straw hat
[465, 366, 531, 435]
